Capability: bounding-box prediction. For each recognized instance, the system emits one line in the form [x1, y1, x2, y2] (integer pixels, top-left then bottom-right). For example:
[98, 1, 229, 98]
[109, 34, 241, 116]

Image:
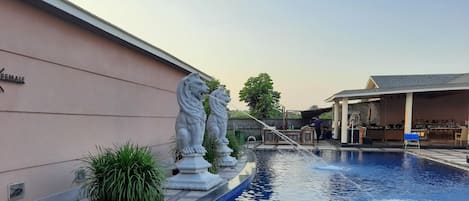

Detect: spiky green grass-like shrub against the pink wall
[83, 143, 165, 201]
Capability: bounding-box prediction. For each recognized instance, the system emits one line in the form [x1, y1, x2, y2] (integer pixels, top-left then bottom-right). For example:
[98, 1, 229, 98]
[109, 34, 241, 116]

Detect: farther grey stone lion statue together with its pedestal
[207, 88, 238, 167]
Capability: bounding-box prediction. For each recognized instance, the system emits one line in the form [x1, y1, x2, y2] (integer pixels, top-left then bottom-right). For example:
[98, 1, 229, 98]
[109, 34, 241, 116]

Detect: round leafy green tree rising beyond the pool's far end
[239, 73, 280, 119]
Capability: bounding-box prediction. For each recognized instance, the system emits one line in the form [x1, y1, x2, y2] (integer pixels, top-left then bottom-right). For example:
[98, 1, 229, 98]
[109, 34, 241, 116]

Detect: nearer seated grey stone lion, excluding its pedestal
[176, 73, 208, 155]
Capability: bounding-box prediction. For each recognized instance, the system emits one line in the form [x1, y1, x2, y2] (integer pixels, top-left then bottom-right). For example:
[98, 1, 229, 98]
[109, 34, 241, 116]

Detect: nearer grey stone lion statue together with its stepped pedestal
[165, 73, 223, 191]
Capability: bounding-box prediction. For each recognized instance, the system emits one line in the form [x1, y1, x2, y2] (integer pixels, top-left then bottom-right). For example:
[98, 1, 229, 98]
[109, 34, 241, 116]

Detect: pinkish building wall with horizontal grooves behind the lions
[0, 1, 186, 201]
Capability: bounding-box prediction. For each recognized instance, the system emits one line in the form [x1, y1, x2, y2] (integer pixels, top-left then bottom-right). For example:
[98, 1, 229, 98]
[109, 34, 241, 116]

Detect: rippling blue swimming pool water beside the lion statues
[236, 151, 469, 201]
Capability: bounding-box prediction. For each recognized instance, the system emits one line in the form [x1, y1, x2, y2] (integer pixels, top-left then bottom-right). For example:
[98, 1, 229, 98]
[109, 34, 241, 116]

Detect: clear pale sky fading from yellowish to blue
[71, 0, 469, 110]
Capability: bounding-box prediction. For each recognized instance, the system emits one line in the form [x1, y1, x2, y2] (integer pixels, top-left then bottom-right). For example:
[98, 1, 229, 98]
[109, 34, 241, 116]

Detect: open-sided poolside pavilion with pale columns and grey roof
[327, 73, 469, 143]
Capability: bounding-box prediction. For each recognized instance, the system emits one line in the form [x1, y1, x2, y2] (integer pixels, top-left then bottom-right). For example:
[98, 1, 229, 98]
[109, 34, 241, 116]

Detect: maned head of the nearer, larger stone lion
[177, 73, 208, 119]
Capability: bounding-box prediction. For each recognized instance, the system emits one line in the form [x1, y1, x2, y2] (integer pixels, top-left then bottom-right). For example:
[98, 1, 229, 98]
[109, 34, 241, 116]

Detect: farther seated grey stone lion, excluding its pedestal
[207, 88, 231, 143]
